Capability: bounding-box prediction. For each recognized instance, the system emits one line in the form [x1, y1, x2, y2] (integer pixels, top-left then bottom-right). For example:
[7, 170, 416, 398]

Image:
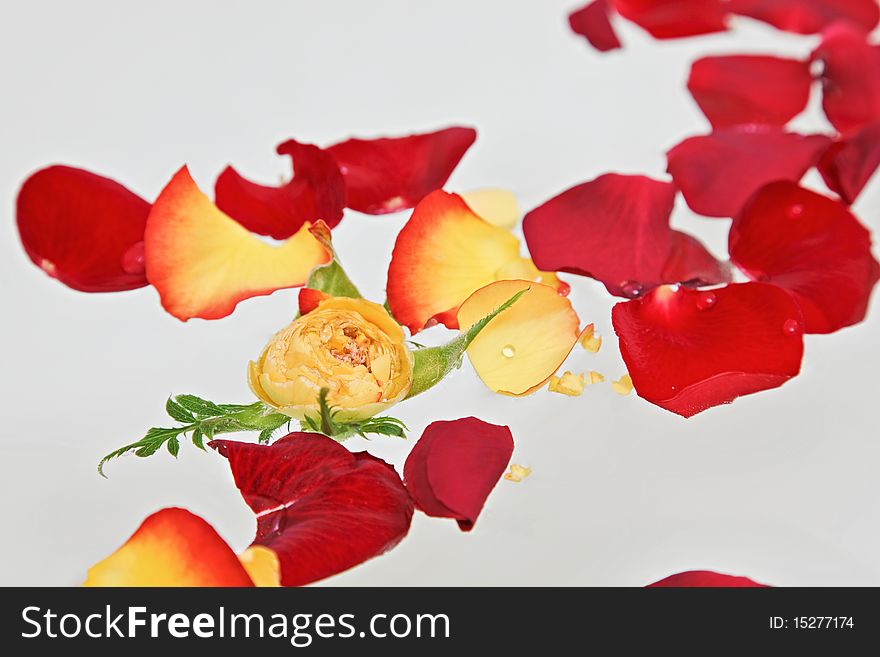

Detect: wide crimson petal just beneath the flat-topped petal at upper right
[667, 125, 831, 217]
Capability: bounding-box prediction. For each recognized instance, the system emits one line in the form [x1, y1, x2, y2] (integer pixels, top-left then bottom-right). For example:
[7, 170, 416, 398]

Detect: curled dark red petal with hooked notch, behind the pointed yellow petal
[214, 139, 345, 240]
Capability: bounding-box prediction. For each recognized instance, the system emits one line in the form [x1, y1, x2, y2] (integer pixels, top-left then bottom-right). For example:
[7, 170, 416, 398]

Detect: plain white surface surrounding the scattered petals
[0, 0, 880, 585]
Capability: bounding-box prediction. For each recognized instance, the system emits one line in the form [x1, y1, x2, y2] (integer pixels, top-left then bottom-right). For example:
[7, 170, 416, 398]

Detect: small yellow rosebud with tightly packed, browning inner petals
[248, 297, 413, 422]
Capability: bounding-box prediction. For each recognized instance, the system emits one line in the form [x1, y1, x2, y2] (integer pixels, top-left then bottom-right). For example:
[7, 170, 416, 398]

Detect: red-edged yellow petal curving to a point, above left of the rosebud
[144, 167, 331, 321]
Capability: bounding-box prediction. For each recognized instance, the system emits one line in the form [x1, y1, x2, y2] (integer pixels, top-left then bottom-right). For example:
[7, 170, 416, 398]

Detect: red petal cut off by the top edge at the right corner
[728, 0, 880, 34]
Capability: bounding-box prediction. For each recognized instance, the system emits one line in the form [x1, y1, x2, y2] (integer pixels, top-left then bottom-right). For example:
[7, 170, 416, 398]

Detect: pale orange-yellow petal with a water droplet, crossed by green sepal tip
[458, 280, 579, 395]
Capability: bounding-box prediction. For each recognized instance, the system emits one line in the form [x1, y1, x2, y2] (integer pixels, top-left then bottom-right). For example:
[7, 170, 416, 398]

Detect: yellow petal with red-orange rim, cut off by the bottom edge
[84, 508, 253, 586]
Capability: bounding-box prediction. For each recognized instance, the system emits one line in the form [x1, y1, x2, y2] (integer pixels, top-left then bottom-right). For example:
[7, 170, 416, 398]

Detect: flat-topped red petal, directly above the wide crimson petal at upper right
[688, 55, 813, 129]
